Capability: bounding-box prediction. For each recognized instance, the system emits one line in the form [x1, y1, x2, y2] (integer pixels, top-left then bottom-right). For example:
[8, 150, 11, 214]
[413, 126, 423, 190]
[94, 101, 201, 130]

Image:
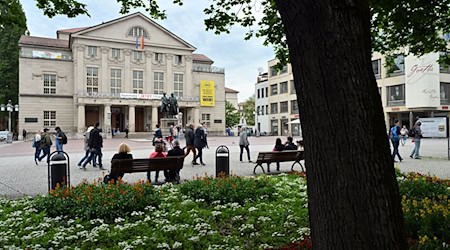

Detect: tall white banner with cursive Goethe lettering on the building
[405, 53, 441, 108]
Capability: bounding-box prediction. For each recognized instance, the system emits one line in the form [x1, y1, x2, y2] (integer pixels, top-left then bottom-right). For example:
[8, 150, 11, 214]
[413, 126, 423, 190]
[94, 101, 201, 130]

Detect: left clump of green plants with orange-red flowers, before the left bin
[36, 179, 160, 221]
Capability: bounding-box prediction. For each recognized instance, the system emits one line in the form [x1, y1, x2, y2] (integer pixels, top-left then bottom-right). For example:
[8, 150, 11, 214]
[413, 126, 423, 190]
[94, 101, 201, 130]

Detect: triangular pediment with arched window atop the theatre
[71, 12, 196, 51]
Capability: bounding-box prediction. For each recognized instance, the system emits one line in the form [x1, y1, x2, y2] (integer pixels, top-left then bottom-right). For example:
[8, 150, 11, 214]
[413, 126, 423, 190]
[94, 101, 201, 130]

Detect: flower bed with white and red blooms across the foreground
[0, 172, 450, 249]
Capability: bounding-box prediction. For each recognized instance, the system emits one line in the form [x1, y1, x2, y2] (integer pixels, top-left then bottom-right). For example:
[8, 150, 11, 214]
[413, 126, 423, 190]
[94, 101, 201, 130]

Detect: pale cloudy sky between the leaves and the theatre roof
[21, 0, 274, 102]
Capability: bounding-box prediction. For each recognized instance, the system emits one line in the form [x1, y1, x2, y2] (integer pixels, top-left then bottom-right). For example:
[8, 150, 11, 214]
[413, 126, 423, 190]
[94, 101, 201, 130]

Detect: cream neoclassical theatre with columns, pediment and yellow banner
[19, 13, 225, 137]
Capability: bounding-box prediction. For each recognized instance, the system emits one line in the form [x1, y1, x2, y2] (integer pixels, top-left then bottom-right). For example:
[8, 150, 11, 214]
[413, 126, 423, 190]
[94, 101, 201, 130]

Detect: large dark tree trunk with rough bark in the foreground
[276, 0, 407, 249]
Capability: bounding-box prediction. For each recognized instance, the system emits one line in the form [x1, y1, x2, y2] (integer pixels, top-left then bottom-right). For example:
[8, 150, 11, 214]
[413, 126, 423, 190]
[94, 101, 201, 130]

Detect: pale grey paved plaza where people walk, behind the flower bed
[0, 136, 450, 197]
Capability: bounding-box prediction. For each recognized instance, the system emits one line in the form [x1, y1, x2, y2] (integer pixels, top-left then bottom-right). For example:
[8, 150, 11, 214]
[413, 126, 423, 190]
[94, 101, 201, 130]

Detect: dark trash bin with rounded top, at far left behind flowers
[48, 151, 70, 192]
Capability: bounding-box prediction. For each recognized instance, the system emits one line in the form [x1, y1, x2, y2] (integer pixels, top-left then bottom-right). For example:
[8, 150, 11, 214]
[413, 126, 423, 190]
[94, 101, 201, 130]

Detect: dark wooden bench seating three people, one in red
[103, 156, 184, 183]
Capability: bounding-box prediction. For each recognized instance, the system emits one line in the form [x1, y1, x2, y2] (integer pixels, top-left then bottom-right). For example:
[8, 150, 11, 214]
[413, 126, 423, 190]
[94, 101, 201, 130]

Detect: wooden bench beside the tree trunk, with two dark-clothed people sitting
[253, 150, 305, 174]
